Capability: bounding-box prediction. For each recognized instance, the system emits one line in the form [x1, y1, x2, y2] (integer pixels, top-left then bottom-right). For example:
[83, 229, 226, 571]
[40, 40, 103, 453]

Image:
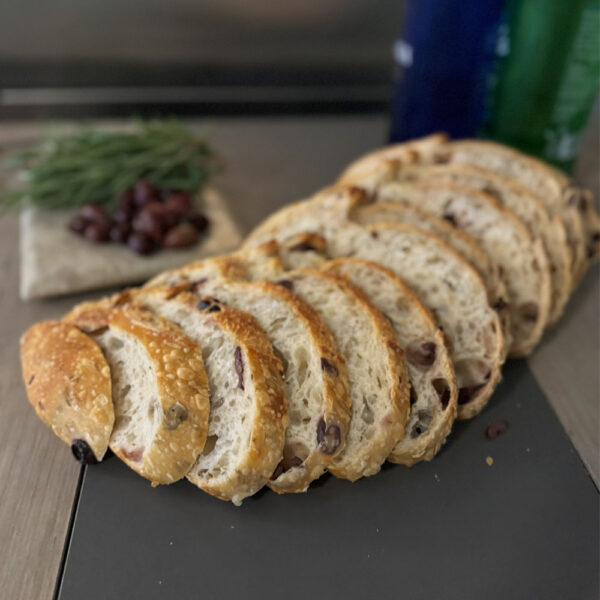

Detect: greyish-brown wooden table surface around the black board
[0, 116, 600, 600]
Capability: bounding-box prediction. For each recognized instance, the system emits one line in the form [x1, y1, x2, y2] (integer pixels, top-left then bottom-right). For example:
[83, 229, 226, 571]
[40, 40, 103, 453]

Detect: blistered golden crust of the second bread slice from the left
[109, 305, 209, 484]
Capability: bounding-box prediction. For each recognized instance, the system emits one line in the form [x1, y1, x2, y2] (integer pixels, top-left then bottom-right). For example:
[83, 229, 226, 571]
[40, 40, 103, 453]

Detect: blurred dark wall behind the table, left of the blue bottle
[0, 0, 402, 117]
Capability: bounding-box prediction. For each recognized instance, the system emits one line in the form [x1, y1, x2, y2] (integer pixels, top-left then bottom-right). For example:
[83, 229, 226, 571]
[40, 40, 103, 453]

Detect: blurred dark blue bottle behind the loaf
[390, 0, 504, 142]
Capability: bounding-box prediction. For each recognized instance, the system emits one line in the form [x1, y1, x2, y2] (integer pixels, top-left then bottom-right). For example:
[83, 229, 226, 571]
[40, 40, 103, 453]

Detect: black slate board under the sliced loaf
[58, 361, 600, 600]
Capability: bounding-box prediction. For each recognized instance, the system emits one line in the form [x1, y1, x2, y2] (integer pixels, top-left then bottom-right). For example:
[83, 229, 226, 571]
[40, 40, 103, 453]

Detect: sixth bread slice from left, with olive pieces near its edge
[322, 258, 458, 466]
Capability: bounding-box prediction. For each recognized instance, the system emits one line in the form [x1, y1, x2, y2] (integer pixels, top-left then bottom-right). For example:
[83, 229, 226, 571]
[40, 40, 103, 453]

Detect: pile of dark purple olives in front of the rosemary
[69, 180, 209, 254]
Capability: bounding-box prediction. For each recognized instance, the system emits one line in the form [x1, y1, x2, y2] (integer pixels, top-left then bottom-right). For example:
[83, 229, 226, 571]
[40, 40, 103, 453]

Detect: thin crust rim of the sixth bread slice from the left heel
[322, 258, 458, 467]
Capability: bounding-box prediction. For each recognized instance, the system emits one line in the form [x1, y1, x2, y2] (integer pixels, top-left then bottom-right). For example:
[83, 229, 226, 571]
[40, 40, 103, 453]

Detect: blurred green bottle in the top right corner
[481, 0, 600, 171]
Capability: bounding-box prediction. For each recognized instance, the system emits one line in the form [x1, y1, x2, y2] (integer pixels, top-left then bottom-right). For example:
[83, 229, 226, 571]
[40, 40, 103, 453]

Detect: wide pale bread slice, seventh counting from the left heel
[244, 188, 505, 419]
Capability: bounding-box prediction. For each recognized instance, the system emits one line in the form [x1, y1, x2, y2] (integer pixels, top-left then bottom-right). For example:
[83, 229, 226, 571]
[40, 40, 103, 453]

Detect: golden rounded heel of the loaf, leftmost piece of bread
[21, 321, 115, 464]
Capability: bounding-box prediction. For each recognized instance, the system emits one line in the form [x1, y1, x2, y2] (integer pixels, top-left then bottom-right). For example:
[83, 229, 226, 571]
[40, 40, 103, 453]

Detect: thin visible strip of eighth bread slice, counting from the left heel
[350, 202, 512, 352]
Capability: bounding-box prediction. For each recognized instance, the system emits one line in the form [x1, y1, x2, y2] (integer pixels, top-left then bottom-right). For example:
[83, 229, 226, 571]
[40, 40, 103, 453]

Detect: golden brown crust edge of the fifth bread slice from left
[302, 269, 410, 481]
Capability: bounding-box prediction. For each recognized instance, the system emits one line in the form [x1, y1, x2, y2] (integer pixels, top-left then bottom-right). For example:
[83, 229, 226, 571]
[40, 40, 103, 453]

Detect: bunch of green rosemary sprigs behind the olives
[0, 119, 219, 211]
